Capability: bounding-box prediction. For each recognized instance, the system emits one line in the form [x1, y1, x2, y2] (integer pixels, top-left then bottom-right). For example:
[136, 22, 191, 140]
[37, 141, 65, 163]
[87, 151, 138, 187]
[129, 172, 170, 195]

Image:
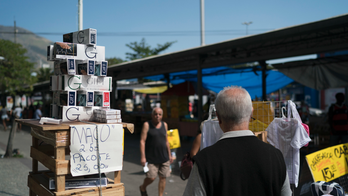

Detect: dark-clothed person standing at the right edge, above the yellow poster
[328, 93, 348, 146]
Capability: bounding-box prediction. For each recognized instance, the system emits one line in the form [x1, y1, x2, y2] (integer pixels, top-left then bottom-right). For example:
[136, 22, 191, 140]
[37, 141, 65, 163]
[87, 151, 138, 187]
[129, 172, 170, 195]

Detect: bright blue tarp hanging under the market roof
[145, 67, 293, 99]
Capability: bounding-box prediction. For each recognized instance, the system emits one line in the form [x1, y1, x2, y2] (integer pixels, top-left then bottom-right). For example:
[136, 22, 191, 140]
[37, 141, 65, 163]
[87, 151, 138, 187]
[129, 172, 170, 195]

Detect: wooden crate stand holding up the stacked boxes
[16, 119, 134, 195]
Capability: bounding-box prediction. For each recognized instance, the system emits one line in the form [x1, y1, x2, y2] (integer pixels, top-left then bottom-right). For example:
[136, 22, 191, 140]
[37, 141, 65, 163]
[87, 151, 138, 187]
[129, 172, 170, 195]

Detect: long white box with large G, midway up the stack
[59, 75, 112, 91]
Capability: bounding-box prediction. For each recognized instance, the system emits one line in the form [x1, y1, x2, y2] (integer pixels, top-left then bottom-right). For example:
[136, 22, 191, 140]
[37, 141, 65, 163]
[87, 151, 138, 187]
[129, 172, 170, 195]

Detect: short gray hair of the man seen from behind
[215, 86, 252, 124]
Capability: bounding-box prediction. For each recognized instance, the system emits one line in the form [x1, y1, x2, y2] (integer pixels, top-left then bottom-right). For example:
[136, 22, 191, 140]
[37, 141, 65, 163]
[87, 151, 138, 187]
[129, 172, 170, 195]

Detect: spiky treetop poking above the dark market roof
[126, 38, 176, 60]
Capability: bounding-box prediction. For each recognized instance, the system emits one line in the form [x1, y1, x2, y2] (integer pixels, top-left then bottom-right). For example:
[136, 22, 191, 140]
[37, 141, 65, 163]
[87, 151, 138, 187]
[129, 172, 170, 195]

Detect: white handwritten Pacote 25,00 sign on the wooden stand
[70, 124, 123, 176]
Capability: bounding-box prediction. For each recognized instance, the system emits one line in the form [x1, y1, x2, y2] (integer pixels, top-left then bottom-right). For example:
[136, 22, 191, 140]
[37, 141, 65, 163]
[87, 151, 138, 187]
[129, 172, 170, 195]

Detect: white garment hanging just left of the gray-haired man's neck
[200, 119, 224, 150]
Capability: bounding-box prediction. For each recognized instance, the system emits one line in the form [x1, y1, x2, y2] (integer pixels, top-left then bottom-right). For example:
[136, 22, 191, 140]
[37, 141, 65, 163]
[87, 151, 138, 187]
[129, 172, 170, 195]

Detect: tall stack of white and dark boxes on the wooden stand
[47, 28, 120, 122]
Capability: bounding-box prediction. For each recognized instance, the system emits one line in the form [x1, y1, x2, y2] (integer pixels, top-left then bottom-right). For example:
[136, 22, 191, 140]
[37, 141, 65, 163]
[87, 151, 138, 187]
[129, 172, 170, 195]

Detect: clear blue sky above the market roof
[0, 0, 348, 60]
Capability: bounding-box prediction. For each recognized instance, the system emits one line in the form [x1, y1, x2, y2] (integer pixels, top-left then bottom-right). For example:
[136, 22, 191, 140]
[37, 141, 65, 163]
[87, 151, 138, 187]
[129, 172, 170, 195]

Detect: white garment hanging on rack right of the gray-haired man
[266, 100, 311, 187]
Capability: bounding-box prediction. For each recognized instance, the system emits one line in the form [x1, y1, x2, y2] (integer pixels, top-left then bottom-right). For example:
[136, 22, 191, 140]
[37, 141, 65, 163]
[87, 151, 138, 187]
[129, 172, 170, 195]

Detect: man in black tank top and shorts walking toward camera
[139, 107, 173, 196]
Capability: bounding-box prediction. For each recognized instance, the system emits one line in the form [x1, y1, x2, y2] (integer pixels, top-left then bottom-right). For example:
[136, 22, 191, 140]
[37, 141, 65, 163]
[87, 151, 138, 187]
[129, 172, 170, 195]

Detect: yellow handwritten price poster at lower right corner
[306, 143, 348, 182]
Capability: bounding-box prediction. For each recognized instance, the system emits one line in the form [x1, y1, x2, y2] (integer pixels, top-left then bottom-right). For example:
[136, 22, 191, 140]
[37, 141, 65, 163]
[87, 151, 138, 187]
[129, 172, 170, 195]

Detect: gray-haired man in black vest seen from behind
[184, 87, 292, 196]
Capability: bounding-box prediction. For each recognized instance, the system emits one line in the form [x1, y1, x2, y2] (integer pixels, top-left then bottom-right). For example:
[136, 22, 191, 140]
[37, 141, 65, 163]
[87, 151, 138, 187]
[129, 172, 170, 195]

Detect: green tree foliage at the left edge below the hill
[0, 39, 36, 95]
